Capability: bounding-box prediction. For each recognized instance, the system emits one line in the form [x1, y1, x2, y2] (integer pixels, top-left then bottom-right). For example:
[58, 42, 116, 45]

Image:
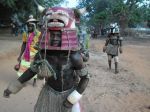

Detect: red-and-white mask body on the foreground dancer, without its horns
[40, 7, 79, 51]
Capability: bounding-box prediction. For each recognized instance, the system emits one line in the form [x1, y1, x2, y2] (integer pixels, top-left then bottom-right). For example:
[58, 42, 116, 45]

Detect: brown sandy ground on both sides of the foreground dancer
[0, 36, 150, 112]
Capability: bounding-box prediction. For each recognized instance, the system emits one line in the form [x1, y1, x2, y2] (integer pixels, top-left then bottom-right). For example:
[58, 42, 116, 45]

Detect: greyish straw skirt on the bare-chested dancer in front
[34, 85, 73, 112]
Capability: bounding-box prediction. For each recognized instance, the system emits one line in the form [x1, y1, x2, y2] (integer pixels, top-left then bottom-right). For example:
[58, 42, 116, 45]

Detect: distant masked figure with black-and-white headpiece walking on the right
[103, 24, 123, 73]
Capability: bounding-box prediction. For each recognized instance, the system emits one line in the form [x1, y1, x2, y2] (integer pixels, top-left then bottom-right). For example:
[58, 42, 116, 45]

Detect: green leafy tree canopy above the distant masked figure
[79, 0, 149, 32]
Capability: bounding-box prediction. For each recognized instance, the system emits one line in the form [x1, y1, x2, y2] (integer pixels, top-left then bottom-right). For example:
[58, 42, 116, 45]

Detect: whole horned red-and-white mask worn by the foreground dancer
[34, 0, 86, 51]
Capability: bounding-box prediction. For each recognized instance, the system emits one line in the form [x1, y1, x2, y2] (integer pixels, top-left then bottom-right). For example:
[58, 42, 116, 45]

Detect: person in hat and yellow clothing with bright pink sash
[15, 15, 41, 86]
